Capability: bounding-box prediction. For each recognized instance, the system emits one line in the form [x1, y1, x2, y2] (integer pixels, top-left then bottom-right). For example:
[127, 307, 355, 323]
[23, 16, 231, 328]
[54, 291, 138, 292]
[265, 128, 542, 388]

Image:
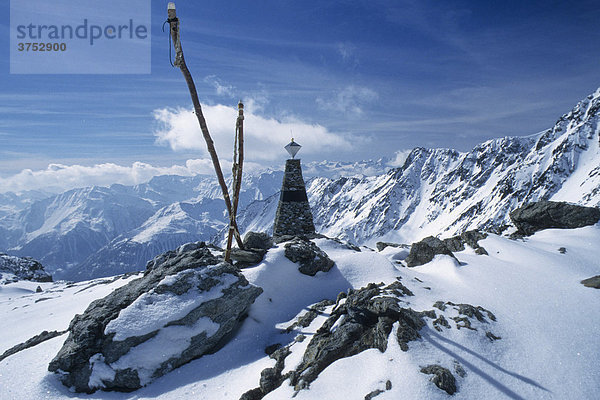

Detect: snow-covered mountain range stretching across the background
[0, 90, 600, 280]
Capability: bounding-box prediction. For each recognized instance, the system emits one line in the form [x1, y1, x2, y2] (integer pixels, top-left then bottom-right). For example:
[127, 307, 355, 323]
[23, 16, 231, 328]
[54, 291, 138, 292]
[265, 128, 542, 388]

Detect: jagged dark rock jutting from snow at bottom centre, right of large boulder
[290, 283, 425, 390]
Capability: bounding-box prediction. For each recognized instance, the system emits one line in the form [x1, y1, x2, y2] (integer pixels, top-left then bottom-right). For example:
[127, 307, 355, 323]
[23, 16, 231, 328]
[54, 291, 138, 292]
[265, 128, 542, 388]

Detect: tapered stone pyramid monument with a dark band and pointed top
[273, 139, 315, 236]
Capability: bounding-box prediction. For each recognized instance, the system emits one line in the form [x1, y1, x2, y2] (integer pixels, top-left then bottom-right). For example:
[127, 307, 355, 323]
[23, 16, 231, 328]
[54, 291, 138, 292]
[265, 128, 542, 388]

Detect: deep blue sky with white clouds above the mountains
[0, 0, 600, 191]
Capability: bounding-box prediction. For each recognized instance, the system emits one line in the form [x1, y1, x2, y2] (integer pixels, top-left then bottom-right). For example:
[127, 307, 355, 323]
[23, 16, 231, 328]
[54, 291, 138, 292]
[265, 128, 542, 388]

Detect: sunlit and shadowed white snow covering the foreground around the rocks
[0, 225, 600, 400]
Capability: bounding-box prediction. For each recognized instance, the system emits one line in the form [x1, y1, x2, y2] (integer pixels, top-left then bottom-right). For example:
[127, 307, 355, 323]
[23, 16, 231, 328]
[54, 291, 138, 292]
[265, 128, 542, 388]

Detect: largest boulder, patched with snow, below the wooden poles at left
[48, 244, 262, 393]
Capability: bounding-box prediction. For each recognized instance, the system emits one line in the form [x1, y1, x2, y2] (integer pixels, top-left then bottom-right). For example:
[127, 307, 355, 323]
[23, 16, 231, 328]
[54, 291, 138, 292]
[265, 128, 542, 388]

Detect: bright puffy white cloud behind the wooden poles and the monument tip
[154, 104, 352, 162]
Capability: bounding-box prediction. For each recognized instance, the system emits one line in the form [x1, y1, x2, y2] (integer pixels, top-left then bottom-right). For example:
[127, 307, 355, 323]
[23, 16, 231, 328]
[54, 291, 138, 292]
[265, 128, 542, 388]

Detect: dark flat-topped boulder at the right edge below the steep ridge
[510, 201, 600, 236]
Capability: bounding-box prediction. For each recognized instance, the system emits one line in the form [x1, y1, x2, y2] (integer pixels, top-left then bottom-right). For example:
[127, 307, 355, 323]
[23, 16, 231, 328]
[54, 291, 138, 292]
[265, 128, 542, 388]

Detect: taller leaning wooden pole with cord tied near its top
[167, 3, 244, 261]
